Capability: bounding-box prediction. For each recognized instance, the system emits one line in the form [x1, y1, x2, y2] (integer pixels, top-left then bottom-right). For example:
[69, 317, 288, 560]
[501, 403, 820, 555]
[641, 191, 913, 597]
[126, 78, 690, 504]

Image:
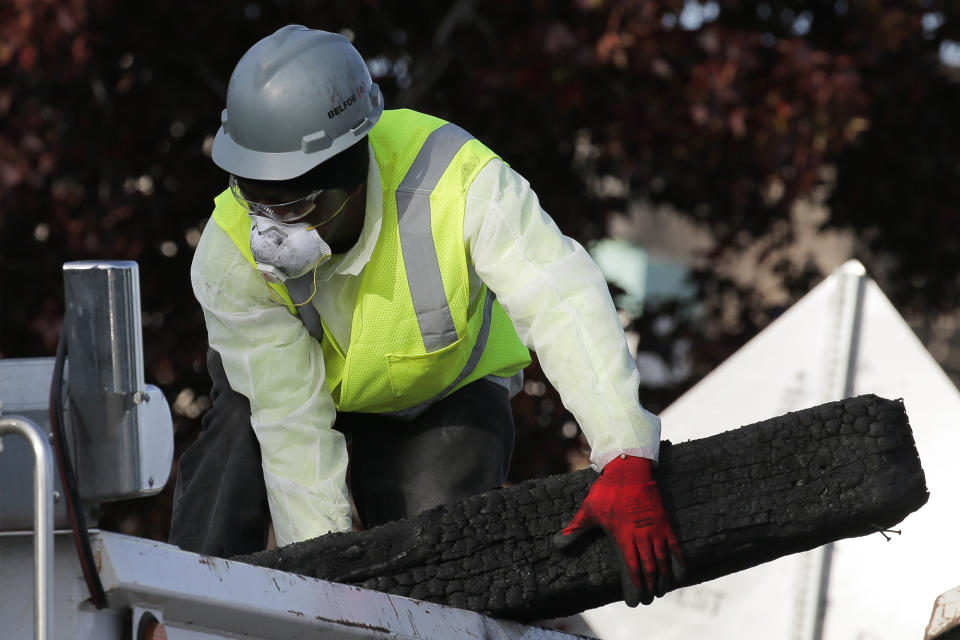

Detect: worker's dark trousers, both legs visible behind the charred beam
[170, 349, 514, 557]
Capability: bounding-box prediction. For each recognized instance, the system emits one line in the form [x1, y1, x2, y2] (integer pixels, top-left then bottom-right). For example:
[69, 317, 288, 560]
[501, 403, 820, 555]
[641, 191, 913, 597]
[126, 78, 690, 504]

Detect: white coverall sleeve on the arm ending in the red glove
[464, 159, 660, 468]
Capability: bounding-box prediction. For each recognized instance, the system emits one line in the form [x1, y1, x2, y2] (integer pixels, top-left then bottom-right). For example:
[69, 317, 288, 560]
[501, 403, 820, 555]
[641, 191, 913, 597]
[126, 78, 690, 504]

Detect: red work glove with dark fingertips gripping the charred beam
[557, 455, 685, 607]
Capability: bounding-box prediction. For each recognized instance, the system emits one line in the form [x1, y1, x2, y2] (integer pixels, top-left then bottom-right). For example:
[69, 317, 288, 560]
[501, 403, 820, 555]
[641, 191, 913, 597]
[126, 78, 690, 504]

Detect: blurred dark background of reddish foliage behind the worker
[0, 0, 960, 539]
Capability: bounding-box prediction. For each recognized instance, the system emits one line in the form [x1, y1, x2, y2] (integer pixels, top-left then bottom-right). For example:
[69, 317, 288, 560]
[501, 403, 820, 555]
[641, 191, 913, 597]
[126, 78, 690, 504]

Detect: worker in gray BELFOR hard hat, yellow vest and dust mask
[171, 25, 682, 605]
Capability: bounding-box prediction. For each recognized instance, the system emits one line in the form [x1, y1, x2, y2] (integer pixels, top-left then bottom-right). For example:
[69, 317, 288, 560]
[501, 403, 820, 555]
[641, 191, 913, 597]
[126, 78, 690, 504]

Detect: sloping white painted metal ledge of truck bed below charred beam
[94, 532, 576, 640]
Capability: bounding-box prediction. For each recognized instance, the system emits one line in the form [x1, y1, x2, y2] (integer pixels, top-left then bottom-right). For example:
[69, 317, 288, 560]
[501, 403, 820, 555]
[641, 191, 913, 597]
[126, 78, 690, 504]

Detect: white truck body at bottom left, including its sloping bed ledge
[0, 531, 588, 640]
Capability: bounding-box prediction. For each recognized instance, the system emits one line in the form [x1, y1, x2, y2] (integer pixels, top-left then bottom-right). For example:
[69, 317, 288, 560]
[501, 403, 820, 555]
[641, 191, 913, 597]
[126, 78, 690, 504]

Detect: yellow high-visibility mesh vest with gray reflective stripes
[207, 109, 530, 413]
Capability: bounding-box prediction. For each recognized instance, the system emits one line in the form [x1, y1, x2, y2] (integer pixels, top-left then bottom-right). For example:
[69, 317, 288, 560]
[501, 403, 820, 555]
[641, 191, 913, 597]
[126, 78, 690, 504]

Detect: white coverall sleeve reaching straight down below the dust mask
[191, 220, 351, 546]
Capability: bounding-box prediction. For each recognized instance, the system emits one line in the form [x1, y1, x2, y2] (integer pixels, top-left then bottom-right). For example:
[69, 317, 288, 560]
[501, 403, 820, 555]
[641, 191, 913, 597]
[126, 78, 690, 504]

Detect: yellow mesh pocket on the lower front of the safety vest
[387, 336, 470, 408]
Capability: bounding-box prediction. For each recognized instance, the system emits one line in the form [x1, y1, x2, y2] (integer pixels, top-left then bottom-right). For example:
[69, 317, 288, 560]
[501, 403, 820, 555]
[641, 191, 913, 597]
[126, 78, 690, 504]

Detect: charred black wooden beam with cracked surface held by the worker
[237, 396, 928, 621]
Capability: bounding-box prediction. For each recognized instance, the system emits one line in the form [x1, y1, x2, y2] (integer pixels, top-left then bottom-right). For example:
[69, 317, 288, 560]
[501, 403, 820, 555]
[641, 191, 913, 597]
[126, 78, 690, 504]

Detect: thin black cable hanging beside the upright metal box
[50, 318, 107, 609]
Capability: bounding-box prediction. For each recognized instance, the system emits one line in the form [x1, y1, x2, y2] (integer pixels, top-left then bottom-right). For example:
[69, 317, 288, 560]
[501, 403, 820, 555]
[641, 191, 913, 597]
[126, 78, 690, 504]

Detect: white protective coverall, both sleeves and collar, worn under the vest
[191, 150, 660, 546]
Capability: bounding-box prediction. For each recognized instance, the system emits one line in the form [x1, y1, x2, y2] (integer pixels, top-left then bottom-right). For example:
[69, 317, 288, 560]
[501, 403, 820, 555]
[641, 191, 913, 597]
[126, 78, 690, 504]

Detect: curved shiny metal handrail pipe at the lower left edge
[0, 416, 53, 640]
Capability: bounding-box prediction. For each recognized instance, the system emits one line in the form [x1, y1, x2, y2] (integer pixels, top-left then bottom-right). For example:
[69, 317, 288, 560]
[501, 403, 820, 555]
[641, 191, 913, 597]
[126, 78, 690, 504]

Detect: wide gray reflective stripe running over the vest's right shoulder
[396, 123, 473, 351]
